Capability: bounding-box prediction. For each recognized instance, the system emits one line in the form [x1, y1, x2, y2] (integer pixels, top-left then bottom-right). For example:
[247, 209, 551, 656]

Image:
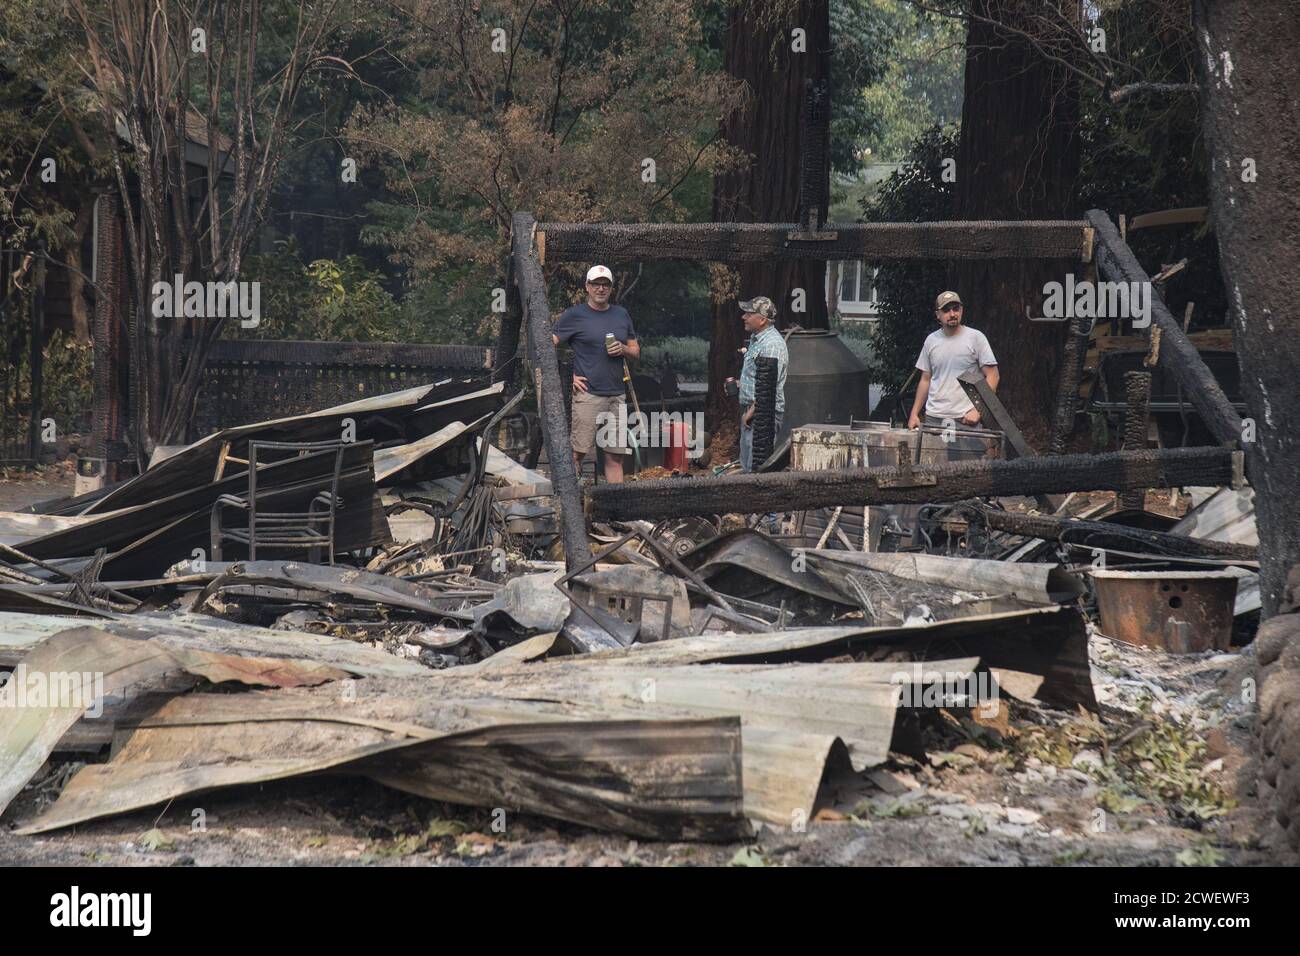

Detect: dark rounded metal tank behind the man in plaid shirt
[776, 329, 871, 445]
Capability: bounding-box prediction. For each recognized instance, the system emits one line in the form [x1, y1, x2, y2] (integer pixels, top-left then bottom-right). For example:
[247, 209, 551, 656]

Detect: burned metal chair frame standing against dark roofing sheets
[211, 441, 348, 564]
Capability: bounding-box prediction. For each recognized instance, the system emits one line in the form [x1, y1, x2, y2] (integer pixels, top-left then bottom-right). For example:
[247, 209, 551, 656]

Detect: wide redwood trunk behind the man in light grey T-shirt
[951, 0, 1083, 449]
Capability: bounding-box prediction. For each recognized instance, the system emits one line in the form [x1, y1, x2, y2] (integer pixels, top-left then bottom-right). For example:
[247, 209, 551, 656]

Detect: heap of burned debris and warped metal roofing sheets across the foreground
[0, 381, 1258, 840]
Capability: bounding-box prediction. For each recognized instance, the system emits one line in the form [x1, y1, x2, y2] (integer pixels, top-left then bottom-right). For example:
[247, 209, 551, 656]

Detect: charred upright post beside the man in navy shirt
[511, 212, 592, 570]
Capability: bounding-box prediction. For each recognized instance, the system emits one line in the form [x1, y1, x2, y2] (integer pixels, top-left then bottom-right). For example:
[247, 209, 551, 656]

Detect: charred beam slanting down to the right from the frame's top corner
[1088, 209, 1242, 447]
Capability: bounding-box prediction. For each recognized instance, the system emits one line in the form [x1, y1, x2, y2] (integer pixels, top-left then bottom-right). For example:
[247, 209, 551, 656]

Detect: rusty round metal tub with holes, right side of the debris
[1092, 571, 1239, 654]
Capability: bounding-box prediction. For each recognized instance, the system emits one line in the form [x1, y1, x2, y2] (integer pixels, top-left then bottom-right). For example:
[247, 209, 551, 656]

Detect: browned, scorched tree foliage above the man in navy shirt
[348, 0, 741, 323]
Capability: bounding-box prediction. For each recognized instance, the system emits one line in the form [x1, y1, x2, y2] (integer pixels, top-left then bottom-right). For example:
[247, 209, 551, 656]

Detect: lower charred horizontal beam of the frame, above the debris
[586, 447, 1240, 520]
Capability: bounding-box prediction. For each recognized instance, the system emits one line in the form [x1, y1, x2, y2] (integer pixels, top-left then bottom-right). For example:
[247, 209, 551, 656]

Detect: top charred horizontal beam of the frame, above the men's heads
[537, 220, 1087, 263]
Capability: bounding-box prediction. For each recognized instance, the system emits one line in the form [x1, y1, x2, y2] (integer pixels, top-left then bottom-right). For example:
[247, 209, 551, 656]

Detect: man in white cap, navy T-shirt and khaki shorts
[551, 265, 641, 481]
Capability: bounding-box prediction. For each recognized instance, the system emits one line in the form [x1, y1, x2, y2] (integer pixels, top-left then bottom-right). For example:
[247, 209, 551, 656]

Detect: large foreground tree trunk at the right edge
[1195, 0, 1300, 617]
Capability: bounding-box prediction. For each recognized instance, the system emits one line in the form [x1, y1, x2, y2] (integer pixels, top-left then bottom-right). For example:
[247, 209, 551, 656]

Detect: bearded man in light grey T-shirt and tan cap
[907, 293, 998, 428]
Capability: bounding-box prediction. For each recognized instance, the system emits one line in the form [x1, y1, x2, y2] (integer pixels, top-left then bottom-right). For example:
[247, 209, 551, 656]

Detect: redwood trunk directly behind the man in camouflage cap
[709, 0, 833, 427]
